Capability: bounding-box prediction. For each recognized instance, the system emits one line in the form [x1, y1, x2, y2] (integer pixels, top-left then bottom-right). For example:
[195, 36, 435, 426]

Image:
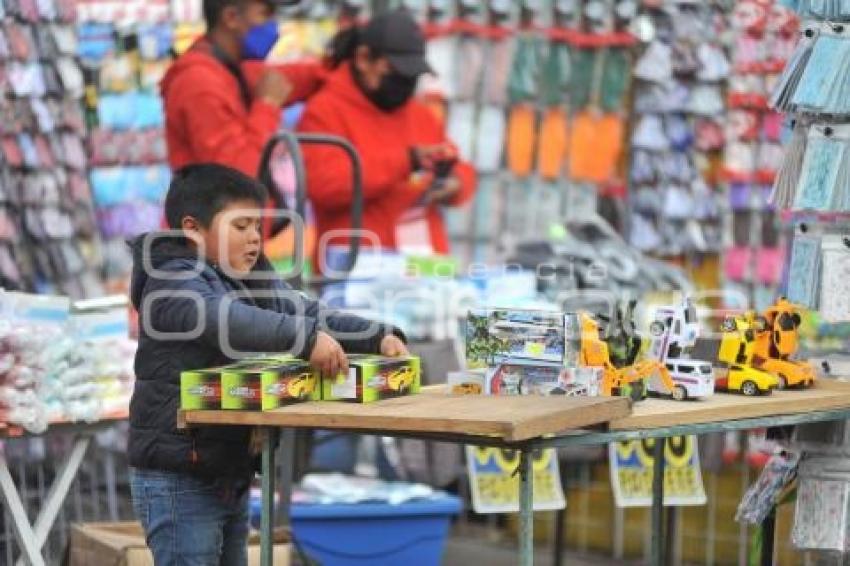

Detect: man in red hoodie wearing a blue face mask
[161, 0, 323, 177]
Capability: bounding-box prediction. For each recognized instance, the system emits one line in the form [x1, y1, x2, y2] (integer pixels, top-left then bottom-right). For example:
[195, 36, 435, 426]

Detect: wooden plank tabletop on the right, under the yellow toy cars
[609, 379, 850, 430]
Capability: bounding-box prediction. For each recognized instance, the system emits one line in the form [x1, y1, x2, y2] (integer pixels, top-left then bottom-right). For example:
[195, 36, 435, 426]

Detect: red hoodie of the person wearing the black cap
[299, 64, 476, 265]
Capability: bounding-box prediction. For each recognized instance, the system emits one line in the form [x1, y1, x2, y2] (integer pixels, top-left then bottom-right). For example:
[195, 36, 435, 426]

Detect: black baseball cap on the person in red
[360, 10, 434, 77]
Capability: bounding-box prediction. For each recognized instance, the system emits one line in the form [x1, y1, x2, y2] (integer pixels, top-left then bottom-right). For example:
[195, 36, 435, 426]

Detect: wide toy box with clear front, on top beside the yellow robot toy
[466, 309, 580, 369]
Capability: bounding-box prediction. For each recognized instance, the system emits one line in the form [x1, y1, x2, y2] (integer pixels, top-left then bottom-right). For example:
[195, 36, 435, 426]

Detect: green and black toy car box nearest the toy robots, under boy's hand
[322, 355, 422, 403]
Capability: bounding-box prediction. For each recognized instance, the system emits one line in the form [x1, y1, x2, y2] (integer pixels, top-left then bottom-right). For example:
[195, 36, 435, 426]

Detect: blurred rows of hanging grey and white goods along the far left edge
[0, 1, 103, 299]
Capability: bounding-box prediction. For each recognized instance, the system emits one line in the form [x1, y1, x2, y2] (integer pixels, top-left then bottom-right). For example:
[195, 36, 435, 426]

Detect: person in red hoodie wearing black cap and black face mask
[299, 11, 476, 269]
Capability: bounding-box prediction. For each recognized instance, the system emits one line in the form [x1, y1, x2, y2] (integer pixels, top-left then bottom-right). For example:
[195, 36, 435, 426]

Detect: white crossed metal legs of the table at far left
[0, 435, 91, 566]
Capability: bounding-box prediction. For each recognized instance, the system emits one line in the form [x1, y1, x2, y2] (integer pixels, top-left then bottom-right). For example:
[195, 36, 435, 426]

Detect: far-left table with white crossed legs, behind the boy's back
[0, 411, 128, 566]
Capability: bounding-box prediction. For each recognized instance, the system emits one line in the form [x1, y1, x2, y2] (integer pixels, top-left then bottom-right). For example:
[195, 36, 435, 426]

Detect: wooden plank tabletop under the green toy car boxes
[179, 386, 630, 443]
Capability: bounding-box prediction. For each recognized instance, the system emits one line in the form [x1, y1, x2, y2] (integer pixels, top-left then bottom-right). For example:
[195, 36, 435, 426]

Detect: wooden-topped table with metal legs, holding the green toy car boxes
[178, 386, 630, 566]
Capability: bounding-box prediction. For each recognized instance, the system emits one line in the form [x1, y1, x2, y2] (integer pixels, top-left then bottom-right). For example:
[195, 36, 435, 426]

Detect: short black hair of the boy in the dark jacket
[165, 163, 269, 230]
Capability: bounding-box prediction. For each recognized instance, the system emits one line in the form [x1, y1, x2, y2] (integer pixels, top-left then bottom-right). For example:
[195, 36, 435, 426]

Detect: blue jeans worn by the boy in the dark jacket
[130, 469, 250, 566]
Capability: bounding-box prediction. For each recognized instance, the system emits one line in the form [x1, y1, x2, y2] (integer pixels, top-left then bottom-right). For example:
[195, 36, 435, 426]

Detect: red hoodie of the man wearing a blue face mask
[161, 38, 324, 177]
